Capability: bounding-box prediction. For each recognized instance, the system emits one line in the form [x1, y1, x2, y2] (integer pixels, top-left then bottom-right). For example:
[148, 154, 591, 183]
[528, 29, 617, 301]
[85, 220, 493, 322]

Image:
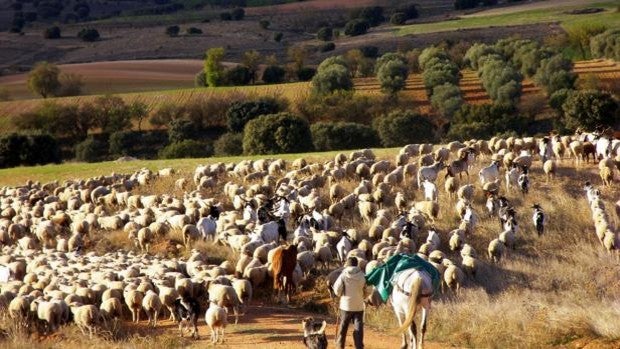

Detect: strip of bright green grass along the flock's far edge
[0, 148, 398, 186]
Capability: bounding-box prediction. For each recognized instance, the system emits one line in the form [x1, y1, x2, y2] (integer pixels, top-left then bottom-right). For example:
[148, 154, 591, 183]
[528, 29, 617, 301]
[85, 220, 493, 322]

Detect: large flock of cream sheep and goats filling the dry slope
[0, 134, 620, 342]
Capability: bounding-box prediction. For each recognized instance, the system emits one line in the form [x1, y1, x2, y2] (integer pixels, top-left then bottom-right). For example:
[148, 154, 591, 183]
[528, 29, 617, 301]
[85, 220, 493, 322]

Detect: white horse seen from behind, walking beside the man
[390, 269, 433, 349]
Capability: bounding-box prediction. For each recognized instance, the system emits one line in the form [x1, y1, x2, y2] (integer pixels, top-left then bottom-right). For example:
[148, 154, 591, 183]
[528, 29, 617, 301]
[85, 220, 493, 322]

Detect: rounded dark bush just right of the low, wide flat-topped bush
[373, 111, 435, 147]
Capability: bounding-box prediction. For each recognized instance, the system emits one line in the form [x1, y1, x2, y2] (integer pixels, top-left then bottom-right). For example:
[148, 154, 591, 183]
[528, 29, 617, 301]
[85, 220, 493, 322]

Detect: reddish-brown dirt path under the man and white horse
[145, 303, 445, 349]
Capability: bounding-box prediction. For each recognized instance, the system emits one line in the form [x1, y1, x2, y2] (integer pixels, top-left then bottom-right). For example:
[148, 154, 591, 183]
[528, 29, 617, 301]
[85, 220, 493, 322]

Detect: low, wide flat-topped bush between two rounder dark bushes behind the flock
[310, 122, 379, 151]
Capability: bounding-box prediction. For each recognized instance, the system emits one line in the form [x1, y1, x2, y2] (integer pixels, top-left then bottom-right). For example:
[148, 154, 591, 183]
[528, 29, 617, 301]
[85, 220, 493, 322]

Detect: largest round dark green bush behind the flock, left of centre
[243, 113, 314, 155]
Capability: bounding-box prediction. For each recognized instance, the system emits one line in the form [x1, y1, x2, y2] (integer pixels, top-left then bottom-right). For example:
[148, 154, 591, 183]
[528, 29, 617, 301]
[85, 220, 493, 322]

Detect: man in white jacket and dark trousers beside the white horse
[334, 257, 366, 349]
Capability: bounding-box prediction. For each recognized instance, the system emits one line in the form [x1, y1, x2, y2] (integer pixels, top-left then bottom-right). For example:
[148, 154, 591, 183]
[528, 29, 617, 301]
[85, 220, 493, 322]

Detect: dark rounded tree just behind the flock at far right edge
[562, 90, 620, 130]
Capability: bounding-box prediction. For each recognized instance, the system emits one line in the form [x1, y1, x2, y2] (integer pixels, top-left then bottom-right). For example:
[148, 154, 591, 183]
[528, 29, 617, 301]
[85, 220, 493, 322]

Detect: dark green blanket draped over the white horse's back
[366, 253, 441, 302]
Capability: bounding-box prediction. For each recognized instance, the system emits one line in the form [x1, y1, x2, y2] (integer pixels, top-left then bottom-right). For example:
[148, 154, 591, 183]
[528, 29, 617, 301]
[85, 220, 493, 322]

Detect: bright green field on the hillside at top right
[395, 1, 620, 36]
